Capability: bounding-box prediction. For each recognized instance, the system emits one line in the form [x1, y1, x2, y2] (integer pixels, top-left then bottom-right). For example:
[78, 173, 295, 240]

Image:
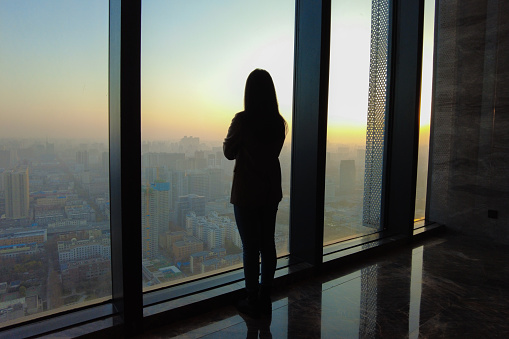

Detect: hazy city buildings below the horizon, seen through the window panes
[0, 111, 428, 327]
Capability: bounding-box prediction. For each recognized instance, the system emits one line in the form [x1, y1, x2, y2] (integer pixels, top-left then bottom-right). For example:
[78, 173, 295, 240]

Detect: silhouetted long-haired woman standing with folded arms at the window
[223, 69, 287, 317]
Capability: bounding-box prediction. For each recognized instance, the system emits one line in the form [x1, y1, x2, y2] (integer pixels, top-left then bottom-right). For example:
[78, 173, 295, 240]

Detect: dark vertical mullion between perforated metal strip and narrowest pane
[382, 0, 424, 236]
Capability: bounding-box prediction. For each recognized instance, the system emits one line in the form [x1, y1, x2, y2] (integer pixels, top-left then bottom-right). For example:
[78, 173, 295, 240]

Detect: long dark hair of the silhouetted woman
[244, 68, 287, 135]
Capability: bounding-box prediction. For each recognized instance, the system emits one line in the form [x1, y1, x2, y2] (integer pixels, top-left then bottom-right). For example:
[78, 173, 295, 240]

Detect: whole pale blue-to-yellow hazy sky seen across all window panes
[0, 0, 431, 143]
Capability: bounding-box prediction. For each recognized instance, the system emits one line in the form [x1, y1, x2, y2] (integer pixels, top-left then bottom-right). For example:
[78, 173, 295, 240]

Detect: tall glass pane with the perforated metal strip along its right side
[324, 0, 389, 245]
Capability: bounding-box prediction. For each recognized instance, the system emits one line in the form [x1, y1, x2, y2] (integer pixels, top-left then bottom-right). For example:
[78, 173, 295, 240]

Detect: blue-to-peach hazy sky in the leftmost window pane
[0, 0, 108, 138]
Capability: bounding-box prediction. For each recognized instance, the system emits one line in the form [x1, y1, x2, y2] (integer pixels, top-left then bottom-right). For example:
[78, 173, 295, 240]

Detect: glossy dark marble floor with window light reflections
[137, 235, 509, 338]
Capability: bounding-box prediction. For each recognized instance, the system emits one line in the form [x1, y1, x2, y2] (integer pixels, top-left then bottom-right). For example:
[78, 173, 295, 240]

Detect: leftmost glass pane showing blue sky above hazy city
[0, 0, 111, 327]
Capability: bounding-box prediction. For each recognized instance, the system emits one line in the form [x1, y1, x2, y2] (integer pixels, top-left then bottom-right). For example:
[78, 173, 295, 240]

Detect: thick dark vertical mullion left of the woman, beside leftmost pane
[109, 0, 143, 334]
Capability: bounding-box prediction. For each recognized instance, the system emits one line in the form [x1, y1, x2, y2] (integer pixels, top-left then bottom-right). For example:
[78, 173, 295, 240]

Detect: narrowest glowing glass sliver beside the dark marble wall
[414, 0, 435, 227]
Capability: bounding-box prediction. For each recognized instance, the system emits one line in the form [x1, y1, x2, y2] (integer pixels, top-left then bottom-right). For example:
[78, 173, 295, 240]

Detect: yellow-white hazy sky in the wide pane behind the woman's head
[142, 0, 295, 140]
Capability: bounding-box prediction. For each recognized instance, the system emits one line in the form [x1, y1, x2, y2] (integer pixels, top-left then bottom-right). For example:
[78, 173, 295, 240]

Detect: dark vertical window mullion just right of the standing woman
[290, 0, 331, 266]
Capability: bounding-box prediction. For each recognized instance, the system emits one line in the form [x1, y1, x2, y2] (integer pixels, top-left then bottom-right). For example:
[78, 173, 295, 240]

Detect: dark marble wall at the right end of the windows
[428, 0, 509, 243]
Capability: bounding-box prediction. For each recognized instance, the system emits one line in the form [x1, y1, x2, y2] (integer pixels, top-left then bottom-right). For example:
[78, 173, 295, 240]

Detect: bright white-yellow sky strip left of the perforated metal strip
[327, 0, 371, 144]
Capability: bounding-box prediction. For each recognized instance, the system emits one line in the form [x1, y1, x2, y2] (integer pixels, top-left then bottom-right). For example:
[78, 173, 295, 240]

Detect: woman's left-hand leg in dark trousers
[233, 205, 260, 297]
